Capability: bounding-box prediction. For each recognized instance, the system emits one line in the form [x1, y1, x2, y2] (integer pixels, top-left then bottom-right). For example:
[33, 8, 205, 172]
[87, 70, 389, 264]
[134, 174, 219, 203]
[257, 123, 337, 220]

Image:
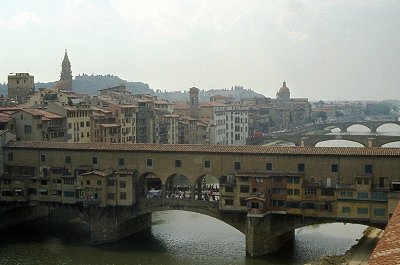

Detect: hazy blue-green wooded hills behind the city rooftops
[0, 74, 263, 101]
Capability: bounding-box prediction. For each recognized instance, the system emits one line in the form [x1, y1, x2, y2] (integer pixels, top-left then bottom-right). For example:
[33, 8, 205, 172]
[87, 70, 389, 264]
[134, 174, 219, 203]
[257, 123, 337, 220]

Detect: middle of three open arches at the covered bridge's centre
[165, 173, 192, 199]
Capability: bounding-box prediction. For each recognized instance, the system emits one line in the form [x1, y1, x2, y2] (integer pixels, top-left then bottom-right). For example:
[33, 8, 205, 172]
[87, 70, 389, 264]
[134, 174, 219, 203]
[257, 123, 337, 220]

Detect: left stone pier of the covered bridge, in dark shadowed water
[85, 207, 151, 244]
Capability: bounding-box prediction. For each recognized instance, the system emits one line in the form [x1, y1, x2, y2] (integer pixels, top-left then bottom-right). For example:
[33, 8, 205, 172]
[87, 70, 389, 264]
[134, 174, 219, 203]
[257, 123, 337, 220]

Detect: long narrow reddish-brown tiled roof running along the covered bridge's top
[6, 141, 400, 157]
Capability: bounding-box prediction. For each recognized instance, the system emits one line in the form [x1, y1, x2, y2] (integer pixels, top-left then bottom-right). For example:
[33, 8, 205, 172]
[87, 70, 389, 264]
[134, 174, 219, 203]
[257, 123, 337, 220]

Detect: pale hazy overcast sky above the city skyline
[0, 0, 400, 100]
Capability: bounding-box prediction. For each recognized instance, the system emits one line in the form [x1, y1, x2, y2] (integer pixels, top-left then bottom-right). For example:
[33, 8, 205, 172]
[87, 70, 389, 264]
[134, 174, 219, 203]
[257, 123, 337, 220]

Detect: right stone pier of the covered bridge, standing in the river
[245, 215, 294, 257]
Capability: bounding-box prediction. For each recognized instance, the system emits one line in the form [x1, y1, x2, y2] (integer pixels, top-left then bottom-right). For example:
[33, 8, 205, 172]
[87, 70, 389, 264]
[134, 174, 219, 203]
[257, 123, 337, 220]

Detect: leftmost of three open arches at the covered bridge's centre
[136, 172, 162, 198]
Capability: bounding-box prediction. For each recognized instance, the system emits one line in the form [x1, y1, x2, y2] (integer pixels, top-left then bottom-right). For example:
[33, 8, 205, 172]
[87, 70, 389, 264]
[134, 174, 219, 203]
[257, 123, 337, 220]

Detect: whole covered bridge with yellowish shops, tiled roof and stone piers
[0, 142, 400, 256]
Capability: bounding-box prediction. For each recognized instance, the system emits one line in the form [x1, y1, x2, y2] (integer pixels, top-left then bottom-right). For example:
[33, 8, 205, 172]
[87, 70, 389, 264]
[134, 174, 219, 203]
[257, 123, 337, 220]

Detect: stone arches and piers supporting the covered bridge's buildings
[65, 198, 386, 257]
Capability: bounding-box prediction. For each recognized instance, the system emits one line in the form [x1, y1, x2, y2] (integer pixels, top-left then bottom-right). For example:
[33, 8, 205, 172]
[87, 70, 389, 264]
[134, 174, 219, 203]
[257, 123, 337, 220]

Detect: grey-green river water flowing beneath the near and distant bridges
[0, 124, 400, 265]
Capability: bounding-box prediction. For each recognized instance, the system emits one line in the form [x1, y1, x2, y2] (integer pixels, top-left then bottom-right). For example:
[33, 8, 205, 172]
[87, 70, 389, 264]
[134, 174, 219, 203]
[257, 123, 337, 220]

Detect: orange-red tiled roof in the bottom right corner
[368, 203, 400, 265]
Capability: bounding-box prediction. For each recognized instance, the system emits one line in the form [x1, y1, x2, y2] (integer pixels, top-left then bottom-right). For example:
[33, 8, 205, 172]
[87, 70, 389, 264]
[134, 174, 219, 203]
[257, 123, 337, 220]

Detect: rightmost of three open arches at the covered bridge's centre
[194, 173, 220, 201]
